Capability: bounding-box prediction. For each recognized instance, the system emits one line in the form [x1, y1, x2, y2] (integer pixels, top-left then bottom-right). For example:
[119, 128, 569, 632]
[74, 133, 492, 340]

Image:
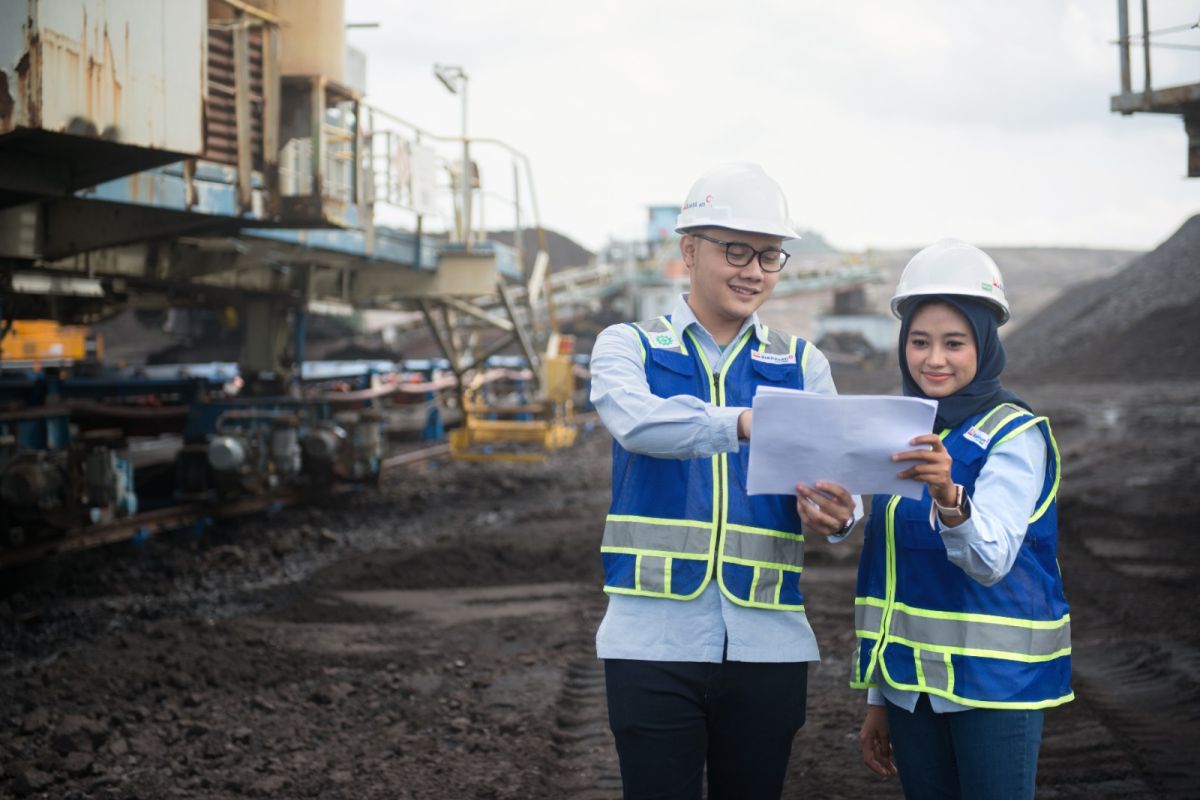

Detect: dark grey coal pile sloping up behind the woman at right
[1004, 216, 1200, 381]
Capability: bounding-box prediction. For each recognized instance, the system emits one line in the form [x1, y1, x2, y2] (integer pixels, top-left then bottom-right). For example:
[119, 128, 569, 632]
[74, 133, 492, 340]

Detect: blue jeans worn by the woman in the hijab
[887, 694, 1044, 800]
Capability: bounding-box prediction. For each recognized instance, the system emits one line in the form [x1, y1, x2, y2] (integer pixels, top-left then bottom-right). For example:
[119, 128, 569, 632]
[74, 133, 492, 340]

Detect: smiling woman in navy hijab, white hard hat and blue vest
[851, 240, 1074, 799]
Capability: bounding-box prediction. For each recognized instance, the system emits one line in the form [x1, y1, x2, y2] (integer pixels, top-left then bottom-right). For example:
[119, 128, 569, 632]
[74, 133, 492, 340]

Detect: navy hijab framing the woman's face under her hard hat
[900, 294, 1032, 431]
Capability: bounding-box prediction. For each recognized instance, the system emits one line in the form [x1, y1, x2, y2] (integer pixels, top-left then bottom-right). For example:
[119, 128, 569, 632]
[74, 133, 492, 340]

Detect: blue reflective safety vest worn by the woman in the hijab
[851, 403, 1074, 709]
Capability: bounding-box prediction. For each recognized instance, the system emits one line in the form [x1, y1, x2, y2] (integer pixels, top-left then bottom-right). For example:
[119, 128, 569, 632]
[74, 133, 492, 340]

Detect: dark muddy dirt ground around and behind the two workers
[0, 381, 1200, 800]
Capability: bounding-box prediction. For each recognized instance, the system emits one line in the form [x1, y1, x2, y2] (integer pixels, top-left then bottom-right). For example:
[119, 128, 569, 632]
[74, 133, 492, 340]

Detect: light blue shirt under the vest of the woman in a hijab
[866, 427, 1046, 714]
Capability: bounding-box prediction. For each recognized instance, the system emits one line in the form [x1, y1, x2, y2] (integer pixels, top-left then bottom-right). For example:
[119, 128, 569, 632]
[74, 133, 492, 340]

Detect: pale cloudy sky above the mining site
[346, 0, 1200, 249]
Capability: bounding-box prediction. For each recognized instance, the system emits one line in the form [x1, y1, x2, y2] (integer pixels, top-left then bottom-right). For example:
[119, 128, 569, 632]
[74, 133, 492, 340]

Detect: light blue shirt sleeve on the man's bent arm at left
[592, 325, 746, 458]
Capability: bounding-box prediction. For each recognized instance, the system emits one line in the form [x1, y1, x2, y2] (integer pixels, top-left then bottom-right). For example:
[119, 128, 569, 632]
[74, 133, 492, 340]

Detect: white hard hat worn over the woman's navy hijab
[892, 239, 1009, 325]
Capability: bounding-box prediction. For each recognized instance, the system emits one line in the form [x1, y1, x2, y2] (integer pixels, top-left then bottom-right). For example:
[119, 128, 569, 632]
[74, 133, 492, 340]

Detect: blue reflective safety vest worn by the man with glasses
[600, 317, 808, 610]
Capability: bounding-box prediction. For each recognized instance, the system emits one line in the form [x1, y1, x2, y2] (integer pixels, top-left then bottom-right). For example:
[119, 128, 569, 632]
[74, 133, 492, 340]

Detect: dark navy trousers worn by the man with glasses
[605, 658, 809, 800]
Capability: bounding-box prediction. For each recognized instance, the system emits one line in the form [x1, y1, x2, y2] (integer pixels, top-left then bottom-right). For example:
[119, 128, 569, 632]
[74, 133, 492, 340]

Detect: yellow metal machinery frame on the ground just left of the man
[450, 337, 576, 462]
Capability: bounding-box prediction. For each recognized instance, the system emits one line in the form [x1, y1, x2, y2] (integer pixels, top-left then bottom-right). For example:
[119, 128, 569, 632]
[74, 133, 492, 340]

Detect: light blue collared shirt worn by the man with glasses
[592, 295, 863, 662]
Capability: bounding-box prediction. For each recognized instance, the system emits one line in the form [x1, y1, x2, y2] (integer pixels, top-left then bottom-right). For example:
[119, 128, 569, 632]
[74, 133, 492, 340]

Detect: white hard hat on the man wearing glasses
[676, 164, 800, 239]
